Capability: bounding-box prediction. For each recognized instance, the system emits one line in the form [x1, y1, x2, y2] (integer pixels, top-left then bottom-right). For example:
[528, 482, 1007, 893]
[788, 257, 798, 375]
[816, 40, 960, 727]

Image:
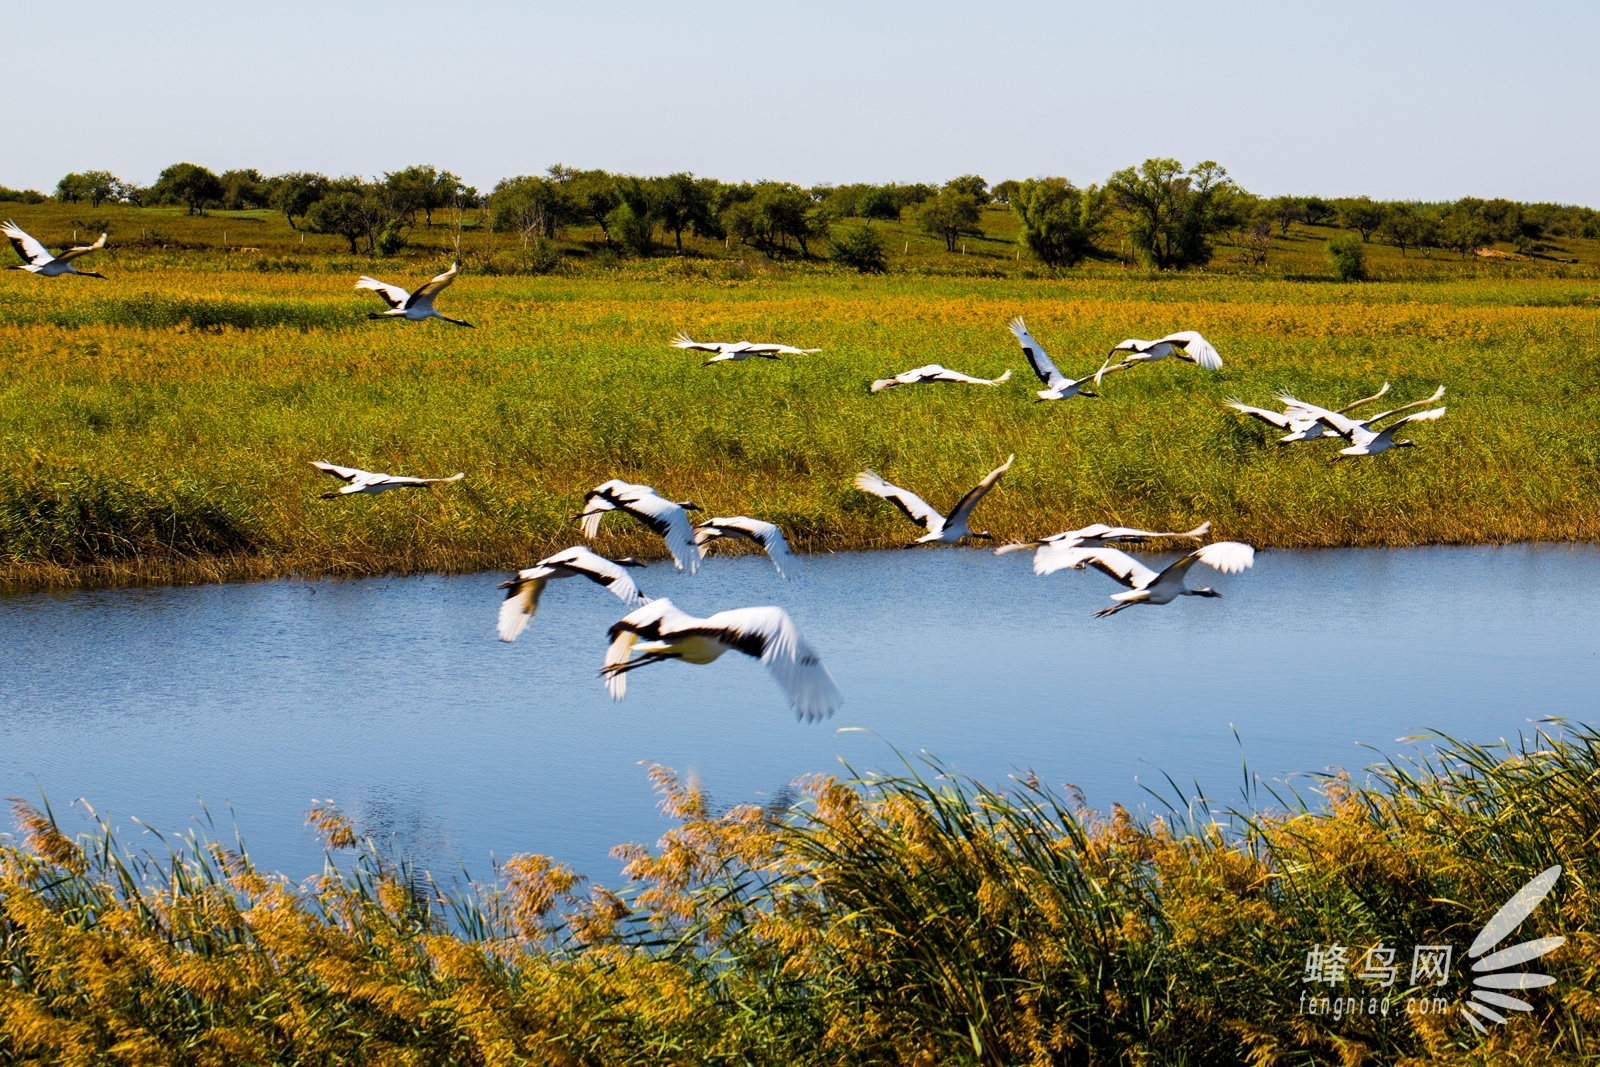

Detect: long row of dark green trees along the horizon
[0, 158, 1600, 270]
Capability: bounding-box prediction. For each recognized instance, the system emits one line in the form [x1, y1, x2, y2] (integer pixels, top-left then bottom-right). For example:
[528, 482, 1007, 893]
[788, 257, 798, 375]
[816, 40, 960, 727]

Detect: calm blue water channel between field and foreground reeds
[0, 545, 1600, 878]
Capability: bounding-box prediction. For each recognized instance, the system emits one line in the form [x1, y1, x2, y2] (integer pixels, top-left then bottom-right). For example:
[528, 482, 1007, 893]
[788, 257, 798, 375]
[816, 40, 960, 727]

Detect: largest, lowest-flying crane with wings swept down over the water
[600, 598, 842, 720]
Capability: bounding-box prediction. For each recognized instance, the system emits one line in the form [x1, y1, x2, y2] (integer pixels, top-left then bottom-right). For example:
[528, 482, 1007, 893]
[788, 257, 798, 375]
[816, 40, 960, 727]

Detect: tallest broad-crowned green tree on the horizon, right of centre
[1106, 158, 1237, 270]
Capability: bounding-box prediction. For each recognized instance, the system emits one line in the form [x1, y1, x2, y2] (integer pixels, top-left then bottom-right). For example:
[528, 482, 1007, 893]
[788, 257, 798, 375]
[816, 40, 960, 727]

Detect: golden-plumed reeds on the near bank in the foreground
[0, 728, 1600, 1067]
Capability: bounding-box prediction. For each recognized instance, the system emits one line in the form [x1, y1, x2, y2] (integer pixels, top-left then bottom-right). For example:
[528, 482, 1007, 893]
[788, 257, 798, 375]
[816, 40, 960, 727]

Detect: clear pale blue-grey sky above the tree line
[12, 0, 1600, 206]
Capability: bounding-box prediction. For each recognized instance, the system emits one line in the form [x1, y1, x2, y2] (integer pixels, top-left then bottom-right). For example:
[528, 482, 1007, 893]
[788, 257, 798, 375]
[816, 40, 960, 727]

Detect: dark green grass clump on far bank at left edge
[0, 466, 262, 566]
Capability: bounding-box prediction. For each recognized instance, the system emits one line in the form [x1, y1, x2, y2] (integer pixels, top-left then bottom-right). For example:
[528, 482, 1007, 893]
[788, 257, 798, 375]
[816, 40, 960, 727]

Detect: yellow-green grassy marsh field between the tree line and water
[0, 205, 1600, 584]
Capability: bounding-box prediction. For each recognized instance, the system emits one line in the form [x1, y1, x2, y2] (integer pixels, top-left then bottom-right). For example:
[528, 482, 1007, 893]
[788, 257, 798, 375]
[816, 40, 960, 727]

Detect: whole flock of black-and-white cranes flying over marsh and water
[0, 231, 1445, 718]
